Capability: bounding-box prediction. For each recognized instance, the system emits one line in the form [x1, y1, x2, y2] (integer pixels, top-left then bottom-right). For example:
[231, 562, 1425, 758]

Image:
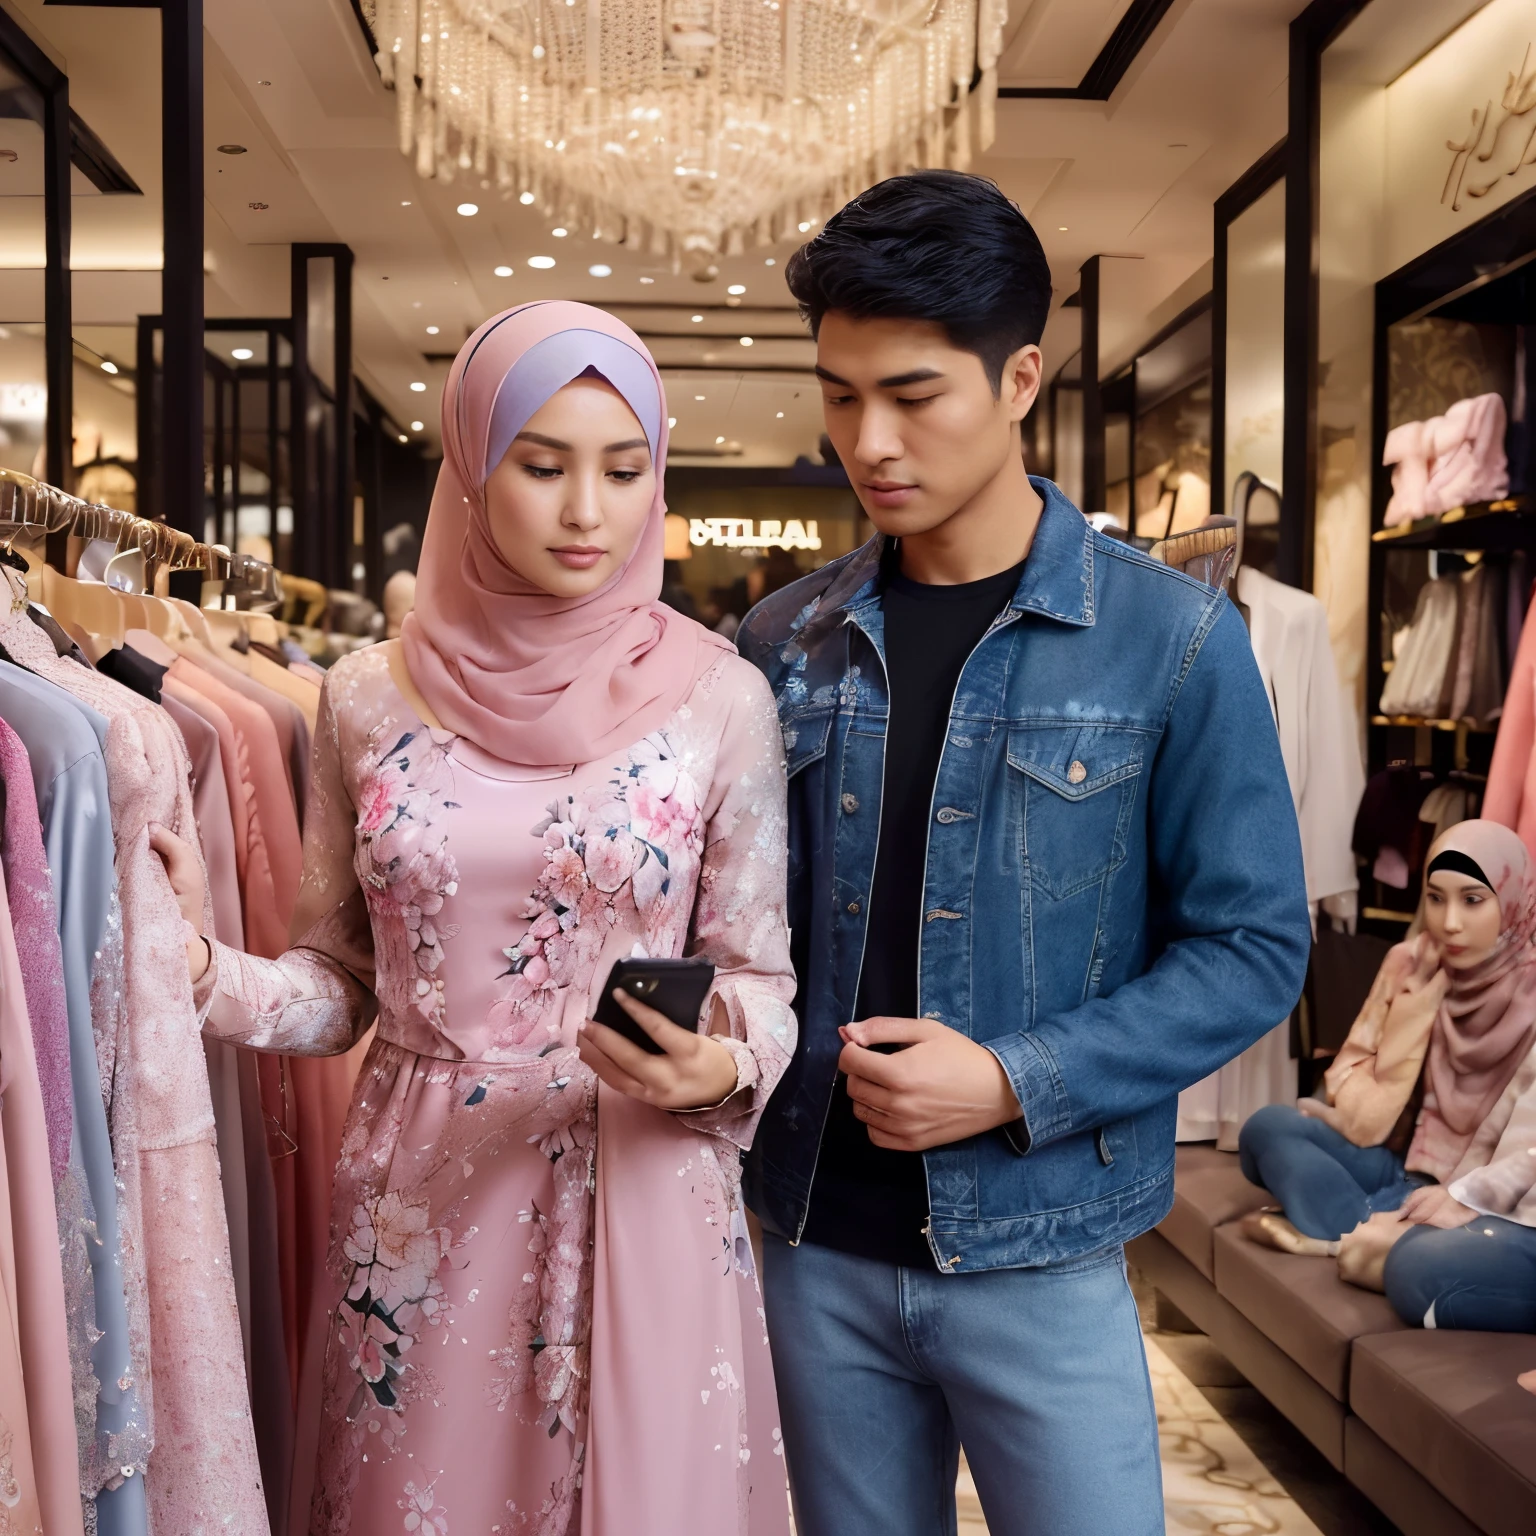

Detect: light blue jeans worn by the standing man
[763, 1235, 1163, 1536]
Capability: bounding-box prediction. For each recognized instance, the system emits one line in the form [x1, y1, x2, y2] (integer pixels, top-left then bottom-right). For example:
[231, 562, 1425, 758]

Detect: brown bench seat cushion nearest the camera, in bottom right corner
[1346, 1329, 1536, 1536]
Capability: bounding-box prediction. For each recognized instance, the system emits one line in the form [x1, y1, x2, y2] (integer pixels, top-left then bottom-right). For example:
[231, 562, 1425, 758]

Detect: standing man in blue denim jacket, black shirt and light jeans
[739, 172, 1309, 1536]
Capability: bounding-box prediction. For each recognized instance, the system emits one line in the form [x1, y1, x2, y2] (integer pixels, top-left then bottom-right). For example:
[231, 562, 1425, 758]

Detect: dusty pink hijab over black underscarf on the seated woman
[1409, 820, 1536, 1166]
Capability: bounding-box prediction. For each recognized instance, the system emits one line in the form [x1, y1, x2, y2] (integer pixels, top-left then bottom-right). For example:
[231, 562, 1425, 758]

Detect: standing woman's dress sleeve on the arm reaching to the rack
[195, 677, 376, 1055]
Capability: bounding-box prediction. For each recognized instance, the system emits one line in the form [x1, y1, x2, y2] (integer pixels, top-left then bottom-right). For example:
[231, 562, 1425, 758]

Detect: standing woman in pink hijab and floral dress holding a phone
[148, 303, 796, 1536]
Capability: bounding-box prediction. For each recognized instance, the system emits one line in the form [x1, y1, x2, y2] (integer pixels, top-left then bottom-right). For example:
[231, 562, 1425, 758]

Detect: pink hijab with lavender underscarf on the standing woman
[401, 300, 730, 768]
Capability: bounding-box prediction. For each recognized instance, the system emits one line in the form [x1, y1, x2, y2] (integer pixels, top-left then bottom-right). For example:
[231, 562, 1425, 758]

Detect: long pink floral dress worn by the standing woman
[200, 651, 794, 1536]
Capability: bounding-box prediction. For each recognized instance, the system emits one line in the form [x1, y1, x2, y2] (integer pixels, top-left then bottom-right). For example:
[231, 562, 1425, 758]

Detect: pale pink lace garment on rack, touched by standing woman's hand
[0, 570, 269, 1536]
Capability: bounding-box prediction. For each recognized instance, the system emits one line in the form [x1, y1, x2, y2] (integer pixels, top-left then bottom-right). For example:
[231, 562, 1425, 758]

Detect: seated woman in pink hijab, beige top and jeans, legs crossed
[1238, 822, 1536, 1265]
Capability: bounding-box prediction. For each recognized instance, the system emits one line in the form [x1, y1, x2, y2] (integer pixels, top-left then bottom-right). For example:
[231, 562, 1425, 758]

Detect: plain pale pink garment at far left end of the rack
[0, 829, 84, 1536]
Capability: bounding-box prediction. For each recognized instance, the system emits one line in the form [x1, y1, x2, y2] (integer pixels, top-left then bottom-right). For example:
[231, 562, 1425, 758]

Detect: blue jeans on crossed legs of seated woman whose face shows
[1238, 1104, 1422, 1238]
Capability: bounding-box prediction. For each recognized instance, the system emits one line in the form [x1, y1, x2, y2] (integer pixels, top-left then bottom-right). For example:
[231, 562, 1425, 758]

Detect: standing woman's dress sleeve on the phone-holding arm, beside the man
[679, 657, 797, 1147]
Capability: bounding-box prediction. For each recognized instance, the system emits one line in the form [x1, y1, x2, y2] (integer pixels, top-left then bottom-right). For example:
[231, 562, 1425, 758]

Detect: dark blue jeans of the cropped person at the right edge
[1385, 1217, 1536, 1333]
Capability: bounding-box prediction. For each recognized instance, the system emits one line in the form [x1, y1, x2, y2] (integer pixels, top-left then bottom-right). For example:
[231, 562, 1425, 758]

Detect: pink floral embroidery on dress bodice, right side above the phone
[490, 731, 703, 1046]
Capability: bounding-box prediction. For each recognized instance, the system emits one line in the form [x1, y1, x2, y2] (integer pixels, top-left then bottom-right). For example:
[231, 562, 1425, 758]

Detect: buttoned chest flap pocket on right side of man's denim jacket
[1008, 725, 1144, 900]
